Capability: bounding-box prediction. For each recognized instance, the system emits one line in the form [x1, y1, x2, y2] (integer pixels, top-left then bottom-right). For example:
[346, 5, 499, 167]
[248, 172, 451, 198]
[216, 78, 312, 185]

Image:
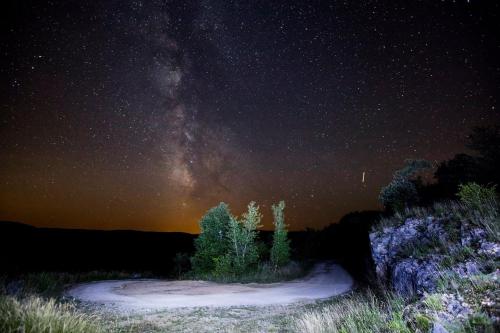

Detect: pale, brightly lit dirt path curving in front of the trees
[68, 263, 353, 313]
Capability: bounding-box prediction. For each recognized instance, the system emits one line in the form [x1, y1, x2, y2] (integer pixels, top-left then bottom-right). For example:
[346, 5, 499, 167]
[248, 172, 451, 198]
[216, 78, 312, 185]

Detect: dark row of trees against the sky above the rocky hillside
[379, 126, 500, 211]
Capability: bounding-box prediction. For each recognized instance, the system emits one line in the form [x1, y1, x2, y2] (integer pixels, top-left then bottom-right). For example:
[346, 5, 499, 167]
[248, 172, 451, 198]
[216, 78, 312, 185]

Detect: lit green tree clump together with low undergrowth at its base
[186, 201, 304, 282]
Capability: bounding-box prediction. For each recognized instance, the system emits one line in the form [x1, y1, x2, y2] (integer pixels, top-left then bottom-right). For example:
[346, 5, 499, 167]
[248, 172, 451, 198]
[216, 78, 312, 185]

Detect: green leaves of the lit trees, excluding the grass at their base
[191, 201, 290, 277]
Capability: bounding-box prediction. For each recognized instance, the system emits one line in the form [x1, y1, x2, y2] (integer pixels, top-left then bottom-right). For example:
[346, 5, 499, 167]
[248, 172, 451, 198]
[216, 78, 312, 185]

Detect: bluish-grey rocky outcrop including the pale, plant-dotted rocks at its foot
[370, 210, 500, 332]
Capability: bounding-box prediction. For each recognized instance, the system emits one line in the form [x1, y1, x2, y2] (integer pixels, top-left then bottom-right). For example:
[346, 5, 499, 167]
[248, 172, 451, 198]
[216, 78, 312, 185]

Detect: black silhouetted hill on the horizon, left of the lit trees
[0, 221, 195, 274]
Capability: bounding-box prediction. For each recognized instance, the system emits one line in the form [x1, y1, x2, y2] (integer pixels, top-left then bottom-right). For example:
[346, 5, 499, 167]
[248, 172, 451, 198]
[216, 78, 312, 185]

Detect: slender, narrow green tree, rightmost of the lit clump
[271, 201, 290, 269]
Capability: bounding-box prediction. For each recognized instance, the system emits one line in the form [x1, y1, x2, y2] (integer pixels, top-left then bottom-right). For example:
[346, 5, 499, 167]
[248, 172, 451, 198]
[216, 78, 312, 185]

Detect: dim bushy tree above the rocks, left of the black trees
[379, 160, 432, 211]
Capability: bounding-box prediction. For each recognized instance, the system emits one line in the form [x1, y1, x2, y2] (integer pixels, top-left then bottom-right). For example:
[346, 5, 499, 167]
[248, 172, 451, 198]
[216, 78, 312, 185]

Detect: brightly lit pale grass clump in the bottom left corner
[0, 296, 106, 333]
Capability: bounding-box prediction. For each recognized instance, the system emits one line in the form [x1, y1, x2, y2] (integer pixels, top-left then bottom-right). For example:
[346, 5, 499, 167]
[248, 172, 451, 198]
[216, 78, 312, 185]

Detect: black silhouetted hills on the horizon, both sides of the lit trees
[0, 217, 380, 280]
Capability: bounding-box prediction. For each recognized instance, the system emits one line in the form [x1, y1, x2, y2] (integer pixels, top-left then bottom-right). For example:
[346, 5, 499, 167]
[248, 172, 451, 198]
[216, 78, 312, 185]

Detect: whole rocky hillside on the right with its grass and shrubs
[370, 203, 500, 332]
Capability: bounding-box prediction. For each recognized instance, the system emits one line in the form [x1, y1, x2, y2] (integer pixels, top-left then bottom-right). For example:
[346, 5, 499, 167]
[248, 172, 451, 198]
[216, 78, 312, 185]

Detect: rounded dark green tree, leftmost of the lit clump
[191, 202, 233, 273]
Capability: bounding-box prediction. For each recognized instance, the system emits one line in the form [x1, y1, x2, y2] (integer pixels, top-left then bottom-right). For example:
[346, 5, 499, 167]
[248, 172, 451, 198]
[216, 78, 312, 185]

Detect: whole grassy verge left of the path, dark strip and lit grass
[0, 271, 155, 333]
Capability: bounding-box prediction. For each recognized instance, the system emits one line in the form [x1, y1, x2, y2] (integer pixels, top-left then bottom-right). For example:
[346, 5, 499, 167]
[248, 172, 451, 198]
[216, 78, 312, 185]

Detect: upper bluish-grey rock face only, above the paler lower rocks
[370, 216, 500, 297]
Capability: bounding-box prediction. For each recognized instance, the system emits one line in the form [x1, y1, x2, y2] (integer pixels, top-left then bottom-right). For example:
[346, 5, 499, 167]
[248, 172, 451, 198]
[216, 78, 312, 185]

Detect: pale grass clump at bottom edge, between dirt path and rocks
[294, 291, 412, 333]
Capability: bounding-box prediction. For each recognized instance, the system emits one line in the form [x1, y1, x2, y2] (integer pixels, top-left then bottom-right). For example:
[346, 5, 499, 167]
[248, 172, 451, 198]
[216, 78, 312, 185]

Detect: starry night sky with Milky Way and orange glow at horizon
[0, 0, 500, 233]
